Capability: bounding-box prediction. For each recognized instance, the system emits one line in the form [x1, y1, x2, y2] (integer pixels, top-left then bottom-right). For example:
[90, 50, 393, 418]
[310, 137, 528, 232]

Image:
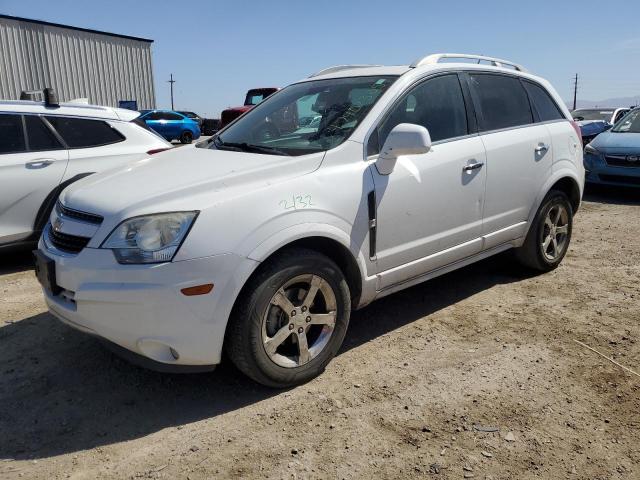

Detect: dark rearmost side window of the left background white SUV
[46, 117, 124, 148]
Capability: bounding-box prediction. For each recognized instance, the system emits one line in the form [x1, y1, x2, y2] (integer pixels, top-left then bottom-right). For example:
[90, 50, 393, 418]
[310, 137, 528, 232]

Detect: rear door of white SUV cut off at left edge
[0, 113, 68, 245]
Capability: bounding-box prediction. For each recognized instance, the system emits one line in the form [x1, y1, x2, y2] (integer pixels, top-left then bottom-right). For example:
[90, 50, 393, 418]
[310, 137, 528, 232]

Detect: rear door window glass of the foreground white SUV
[469, 73, 533, 132]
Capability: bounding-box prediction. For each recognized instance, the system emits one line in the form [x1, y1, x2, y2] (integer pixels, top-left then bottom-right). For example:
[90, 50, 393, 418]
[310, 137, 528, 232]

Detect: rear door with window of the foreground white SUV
[468, 72, 553, 248]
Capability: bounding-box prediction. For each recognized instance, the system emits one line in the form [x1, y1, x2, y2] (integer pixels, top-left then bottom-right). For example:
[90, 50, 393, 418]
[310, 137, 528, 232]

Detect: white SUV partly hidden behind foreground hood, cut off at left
[0, 92, 171, 248]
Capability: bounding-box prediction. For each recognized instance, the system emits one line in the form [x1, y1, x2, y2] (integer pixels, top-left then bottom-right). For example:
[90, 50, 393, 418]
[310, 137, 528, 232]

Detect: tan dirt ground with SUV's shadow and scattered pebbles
[0, 185, 640, 479]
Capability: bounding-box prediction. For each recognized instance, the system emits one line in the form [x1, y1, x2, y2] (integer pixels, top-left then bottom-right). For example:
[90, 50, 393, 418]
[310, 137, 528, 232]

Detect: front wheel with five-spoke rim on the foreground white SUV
[225, 248, 351, 388]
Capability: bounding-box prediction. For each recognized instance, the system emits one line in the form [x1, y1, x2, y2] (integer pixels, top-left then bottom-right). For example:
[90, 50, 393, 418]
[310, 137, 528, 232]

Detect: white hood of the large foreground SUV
[60, 147, 324, 218]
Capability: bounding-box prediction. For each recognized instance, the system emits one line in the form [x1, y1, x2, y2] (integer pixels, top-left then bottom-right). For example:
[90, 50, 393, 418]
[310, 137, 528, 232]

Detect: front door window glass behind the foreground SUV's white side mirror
[376, 75, 468, 155]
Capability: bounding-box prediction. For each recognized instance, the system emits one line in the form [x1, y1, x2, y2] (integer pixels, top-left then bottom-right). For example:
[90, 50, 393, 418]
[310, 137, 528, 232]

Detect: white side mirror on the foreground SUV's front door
[376, 123, 431, 175]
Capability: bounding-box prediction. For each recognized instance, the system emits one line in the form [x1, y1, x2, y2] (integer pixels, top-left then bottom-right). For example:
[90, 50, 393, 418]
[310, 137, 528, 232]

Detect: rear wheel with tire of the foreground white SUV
[515, 190, 573, 272]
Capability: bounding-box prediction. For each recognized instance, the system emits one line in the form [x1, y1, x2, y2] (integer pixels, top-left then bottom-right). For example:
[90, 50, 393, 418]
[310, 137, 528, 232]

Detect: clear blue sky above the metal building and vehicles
[0, 0, 640, 117]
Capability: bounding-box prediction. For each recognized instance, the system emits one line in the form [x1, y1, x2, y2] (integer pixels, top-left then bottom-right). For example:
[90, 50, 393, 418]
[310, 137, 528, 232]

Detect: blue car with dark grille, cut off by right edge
[584, 108, 640, 187]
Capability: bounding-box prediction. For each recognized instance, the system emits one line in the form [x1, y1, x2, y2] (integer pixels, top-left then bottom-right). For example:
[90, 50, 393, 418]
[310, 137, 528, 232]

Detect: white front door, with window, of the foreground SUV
[370, 74, 487, 290]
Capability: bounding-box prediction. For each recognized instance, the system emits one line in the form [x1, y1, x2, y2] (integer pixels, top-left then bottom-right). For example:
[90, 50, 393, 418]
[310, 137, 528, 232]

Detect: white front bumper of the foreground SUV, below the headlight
[39, 240, 256, 366]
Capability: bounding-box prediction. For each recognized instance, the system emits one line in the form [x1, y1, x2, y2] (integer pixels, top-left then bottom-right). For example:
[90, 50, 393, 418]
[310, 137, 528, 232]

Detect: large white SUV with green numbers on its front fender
[37, 54, 584, 387]
